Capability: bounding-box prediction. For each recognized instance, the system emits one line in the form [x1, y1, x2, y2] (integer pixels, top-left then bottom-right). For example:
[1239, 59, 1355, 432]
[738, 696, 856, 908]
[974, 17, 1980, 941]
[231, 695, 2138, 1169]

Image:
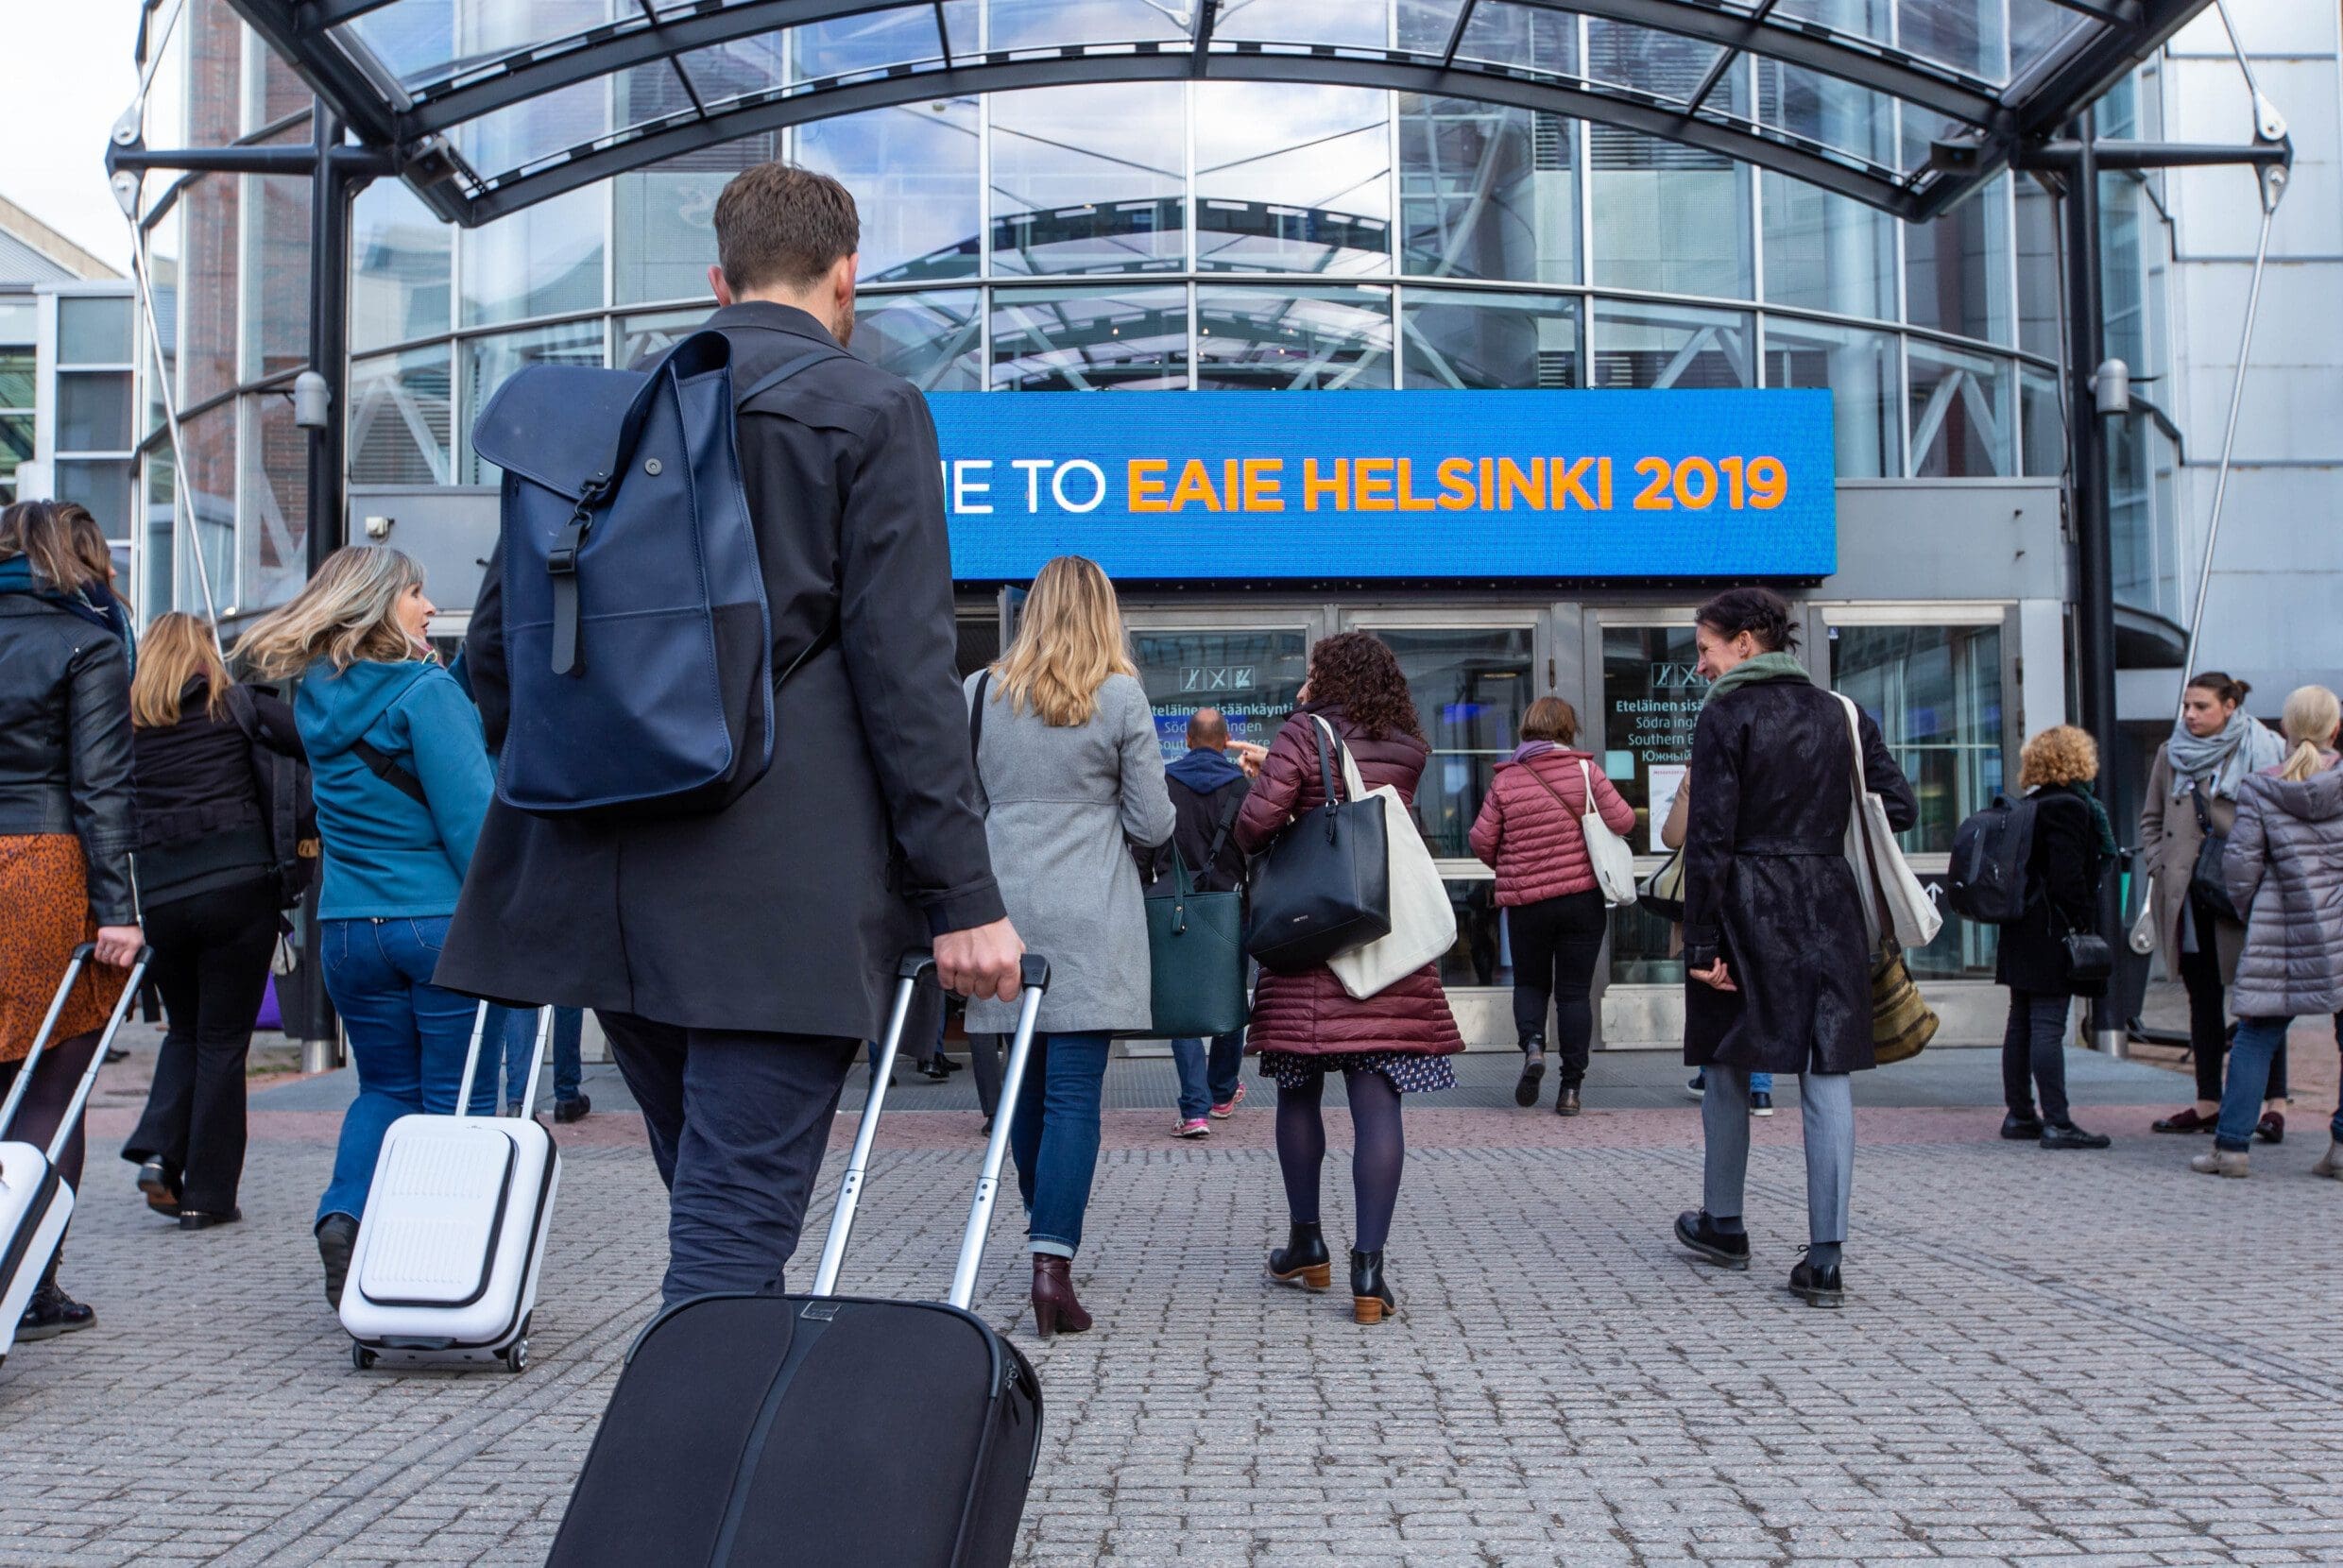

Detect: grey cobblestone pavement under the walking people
[0, 1052, 2343, 1568]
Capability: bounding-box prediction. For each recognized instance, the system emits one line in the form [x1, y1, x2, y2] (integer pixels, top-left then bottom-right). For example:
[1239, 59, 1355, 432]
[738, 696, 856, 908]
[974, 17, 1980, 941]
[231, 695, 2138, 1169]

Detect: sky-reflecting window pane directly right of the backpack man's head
[806, 99, 982, 283]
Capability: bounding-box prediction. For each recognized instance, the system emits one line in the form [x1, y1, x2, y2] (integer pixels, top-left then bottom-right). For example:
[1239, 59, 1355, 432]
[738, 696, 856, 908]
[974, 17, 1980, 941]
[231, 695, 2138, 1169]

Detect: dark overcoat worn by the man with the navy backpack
[434, 302, 1002, 1038]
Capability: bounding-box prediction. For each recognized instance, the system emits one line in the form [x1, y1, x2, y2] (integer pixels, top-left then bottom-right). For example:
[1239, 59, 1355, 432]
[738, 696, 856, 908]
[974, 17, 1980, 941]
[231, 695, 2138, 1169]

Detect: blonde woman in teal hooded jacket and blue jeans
[244, 546, 497, 1305]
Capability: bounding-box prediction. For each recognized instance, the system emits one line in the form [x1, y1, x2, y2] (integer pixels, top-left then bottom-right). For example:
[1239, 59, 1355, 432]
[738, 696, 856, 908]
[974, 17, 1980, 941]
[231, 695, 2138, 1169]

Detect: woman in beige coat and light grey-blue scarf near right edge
[2139, 671, 2286, 1144]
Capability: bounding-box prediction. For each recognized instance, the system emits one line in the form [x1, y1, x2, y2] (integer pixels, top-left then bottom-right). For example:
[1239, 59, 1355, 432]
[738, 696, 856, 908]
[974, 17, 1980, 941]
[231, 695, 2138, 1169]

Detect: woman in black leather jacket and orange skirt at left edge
[0, 502, 145, 1340]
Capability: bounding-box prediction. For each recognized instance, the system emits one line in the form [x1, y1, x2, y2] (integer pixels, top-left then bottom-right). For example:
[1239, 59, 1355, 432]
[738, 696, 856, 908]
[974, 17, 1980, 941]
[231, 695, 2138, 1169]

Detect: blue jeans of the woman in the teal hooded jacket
[316, 916, 497, 1219]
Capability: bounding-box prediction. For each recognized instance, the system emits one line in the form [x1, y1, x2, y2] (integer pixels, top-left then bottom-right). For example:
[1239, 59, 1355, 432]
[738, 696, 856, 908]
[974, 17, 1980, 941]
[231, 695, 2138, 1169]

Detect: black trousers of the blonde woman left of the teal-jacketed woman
[122, 881, 277, 1214]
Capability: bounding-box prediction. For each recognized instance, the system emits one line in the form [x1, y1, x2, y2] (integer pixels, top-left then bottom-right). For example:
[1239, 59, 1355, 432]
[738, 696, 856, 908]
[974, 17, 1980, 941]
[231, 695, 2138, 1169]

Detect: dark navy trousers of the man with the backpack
[597, 1013, 863, 1305]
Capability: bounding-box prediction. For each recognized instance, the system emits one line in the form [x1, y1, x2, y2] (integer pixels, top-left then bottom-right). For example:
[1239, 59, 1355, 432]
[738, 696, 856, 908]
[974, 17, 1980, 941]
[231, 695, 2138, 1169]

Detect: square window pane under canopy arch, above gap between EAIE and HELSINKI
[1195, 83, 1392, 274]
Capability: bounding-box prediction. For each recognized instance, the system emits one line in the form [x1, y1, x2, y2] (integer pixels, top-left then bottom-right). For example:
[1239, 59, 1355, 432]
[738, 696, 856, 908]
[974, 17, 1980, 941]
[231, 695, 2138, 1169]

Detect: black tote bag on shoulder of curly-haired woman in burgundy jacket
[1244, 724, 1392, 975]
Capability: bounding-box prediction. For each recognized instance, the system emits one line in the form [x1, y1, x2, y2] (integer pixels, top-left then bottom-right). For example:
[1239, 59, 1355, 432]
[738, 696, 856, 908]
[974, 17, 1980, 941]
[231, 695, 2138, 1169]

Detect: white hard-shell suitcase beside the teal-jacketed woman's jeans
[342, 1003, 562, 1372]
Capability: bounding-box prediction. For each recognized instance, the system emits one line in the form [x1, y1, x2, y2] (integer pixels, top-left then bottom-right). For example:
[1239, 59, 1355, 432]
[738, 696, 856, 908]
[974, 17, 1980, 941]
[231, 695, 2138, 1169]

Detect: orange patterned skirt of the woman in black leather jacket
[0, 832, 127, 1062]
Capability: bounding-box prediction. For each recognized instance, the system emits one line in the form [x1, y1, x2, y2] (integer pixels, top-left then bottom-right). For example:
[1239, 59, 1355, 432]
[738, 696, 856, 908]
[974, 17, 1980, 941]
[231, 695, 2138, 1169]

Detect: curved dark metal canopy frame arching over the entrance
[215, 0, 2207, 228]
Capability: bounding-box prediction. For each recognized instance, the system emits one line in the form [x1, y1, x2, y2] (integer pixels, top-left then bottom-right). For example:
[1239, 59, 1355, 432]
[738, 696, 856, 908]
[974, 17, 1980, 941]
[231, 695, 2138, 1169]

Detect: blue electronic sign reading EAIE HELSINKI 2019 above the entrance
[928, 389, 1837, 581]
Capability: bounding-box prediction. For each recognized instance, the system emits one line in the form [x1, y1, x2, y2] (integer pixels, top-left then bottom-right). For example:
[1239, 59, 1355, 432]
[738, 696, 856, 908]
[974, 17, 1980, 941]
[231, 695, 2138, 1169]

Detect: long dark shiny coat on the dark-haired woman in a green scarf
[1685, 680, 1919, 1073]
